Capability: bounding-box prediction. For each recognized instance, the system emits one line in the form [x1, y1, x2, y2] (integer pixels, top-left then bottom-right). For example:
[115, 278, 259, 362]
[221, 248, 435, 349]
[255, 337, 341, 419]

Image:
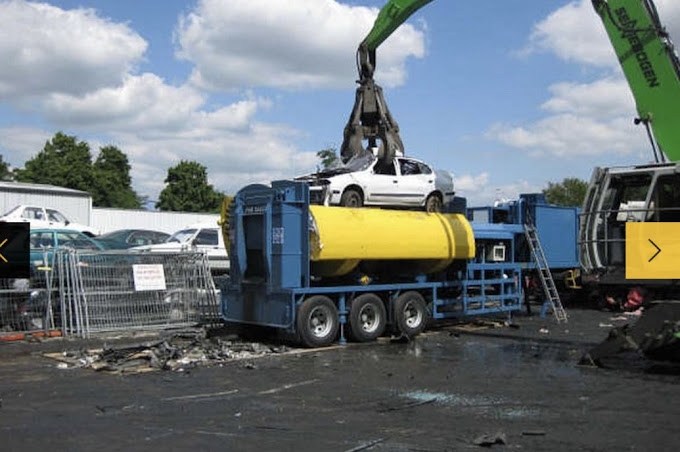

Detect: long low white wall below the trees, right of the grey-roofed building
[91, 207, 220, 234]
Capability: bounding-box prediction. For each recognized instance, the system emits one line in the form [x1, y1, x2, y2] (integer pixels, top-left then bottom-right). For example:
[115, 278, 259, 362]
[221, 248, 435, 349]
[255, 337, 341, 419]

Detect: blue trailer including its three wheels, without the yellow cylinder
[218, 181, 576, 347]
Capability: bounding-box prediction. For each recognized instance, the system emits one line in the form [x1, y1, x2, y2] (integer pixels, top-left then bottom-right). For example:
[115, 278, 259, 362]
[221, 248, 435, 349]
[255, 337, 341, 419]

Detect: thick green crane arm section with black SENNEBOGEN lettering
[592, 0, 680, 161]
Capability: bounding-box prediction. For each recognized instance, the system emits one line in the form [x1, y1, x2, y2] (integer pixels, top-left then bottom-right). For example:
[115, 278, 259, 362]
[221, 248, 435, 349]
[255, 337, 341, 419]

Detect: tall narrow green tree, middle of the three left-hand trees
[90, 146, 141, 209]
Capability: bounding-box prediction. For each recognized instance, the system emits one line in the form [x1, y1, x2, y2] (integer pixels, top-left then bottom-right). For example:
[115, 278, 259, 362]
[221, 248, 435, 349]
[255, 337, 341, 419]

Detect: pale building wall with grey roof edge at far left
[0, 182, 92, 225]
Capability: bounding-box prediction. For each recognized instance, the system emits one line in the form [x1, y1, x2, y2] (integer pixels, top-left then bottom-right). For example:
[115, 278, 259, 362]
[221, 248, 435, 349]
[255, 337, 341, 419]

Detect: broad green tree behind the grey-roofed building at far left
[16, 132, 92, 191]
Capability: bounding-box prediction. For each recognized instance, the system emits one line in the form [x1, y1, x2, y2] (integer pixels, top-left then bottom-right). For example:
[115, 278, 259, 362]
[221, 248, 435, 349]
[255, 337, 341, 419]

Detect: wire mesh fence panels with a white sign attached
[56, 251, 218, 336]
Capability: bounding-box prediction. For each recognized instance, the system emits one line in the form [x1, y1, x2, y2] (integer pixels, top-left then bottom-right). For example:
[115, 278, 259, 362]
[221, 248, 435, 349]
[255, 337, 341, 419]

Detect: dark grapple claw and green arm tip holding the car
[340, 0, 433, 162]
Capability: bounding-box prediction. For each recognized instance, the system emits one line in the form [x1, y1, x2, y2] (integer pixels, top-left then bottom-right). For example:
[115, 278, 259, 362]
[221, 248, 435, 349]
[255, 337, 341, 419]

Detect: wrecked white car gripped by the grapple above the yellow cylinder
[296, 153, 454, 212]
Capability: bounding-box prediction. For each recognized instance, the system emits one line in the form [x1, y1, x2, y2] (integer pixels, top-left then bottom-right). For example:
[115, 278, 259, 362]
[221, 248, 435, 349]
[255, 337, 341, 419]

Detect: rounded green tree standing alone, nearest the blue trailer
[156, 160, 224, 212]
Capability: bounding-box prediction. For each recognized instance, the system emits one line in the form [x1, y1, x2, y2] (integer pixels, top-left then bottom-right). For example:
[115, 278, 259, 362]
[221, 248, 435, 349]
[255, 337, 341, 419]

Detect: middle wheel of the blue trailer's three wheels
[348, 293, 387, 342]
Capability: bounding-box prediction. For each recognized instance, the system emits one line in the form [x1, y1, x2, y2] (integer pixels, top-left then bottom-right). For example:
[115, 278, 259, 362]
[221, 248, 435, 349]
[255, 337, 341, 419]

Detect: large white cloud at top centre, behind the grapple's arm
[176, 0, 424, 90]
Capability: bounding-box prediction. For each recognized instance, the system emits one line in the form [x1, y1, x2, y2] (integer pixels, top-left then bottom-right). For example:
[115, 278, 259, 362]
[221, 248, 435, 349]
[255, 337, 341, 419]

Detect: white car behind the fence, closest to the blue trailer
[131, 223, 229, 273]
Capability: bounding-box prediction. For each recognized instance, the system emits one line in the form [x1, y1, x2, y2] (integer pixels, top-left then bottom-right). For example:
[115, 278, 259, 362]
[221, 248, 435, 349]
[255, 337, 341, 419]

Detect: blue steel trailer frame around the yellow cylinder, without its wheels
[219, 181, 580, 345]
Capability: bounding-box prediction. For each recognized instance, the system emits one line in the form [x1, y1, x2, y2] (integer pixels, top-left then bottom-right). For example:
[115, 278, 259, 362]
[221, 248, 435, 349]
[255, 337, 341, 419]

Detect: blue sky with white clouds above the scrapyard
[0, 0, 680, 205]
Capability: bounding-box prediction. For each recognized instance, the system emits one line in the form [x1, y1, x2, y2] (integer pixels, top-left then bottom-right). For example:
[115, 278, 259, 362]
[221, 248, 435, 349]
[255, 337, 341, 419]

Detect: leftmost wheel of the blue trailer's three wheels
[297, 295, 340, 347]
